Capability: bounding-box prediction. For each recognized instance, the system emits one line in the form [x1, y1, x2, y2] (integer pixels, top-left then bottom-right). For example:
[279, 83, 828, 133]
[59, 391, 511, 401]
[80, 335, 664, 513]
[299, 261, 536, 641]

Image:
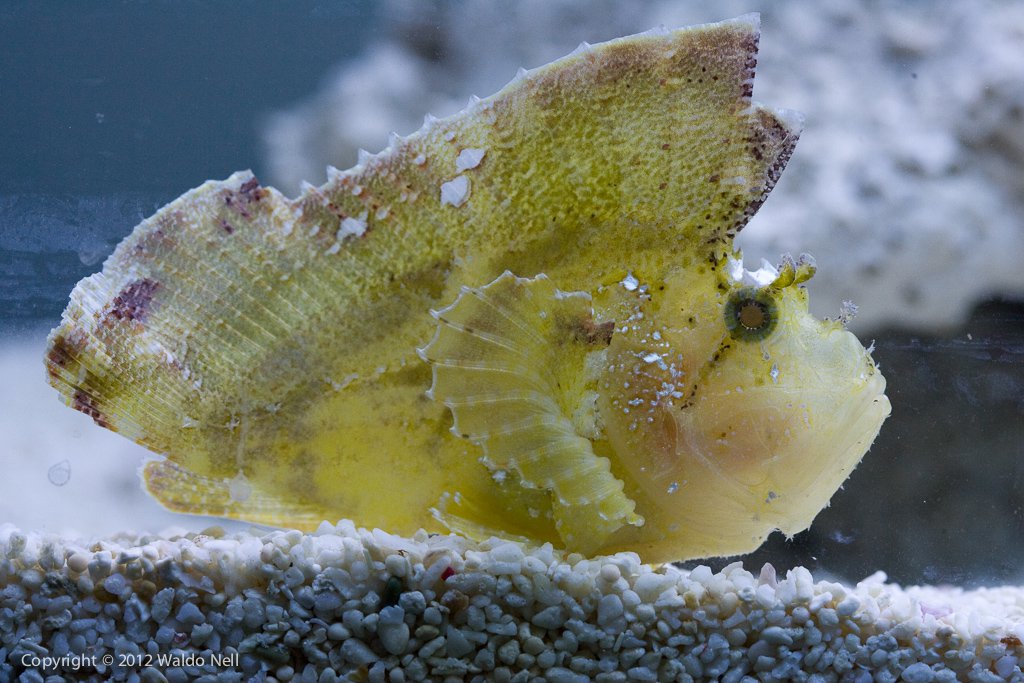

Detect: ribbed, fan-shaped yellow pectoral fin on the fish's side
[421, 271, 643, 550]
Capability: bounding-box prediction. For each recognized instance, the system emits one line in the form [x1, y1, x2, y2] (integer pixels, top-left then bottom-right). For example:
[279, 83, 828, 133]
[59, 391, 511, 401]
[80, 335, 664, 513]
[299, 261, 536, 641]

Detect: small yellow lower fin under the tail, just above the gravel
[142, 460, 324, 528]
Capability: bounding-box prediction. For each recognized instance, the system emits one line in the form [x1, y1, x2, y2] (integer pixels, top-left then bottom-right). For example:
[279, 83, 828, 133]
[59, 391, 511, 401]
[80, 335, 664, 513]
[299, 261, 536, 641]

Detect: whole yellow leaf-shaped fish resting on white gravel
[46, 15, 890, 562]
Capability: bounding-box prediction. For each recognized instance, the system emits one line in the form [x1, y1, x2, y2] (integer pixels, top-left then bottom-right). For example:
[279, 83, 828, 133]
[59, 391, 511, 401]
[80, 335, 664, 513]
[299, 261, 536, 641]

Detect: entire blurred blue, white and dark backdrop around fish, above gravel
[0, 0, 1024, 586]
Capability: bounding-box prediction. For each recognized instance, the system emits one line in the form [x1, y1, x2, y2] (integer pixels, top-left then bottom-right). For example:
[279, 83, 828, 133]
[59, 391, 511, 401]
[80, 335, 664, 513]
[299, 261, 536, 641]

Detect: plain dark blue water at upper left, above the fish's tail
[0, 0, 376, 334]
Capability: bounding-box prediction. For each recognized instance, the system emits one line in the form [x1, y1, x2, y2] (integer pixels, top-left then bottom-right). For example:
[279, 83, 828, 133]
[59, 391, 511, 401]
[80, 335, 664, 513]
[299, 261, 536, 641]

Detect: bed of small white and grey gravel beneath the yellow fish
[0, 522, 1024, 683]
